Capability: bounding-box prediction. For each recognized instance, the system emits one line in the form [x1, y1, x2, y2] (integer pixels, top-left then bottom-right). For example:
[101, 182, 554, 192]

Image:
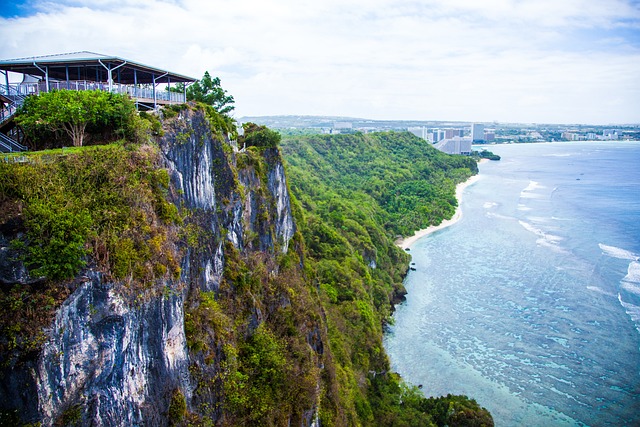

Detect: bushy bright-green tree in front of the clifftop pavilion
[16, 90, 135, 147]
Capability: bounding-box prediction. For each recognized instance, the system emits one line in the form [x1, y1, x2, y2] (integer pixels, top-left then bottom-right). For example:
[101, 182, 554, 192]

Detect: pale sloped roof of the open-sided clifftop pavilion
[0, 51, 197, 84]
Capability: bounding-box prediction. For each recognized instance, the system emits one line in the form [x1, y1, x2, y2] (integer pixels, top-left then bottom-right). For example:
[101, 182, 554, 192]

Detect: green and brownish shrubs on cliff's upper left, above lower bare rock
[0, 144, 180, 284]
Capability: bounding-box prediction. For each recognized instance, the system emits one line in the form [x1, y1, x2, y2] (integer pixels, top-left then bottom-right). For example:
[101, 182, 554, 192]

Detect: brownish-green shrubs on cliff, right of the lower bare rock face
[185, 146, 326, 426]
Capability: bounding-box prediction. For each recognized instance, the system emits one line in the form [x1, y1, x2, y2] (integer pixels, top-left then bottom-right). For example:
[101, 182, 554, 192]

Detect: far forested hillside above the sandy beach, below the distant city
[282, 132, 477, 235]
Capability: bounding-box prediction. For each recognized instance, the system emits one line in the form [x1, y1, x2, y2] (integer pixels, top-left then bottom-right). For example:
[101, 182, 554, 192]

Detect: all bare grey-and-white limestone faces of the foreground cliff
[0, 109, 310, 426]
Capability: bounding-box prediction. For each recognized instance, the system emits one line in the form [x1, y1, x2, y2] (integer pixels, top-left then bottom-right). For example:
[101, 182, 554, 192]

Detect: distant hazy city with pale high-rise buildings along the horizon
[239, 116, 640, 154]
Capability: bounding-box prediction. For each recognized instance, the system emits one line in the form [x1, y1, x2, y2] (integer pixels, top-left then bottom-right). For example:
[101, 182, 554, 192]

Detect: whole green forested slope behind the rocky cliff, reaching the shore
[281, 132, 493, 426]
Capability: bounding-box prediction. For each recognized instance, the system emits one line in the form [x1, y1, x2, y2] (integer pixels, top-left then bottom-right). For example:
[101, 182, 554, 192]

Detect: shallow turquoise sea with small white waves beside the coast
[385, 142, 640, 426]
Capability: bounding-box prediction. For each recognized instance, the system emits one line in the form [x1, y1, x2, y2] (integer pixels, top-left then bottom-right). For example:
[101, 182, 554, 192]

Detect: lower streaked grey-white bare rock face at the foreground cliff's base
[34, 273, 190, 426]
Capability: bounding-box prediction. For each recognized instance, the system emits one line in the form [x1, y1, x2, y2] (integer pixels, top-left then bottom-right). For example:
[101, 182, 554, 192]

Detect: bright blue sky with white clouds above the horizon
[0, 0, 640, 124]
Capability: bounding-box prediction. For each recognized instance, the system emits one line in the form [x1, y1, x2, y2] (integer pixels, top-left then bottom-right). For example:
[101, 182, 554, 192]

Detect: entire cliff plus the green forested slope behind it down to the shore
[0, 105, 492, 426]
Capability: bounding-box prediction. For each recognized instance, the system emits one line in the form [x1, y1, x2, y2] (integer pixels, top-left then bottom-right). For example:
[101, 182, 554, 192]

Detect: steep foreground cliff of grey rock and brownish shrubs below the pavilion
[0, 108, 324, 426]
